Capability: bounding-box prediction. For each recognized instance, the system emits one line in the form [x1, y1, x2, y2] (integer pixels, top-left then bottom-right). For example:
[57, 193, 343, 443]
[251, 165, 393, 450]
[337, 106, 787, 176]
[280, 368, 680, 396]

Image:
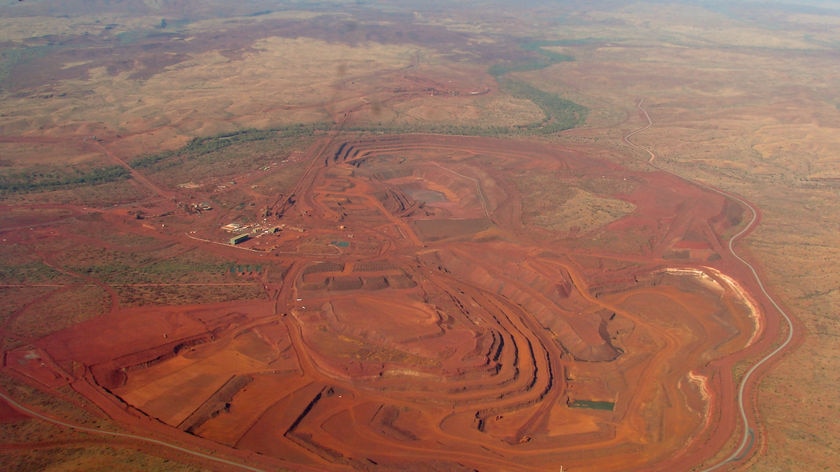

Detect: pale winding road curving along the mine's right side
[624, 99, 793, 472]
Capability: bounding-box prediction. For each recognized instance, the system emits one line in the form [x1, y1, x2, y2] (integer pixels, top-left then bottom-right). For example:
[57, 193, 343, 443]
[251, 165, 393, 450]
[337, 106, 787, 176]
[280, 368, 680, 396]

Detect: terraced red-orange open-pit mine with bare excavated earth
[0, 135, 779, 471]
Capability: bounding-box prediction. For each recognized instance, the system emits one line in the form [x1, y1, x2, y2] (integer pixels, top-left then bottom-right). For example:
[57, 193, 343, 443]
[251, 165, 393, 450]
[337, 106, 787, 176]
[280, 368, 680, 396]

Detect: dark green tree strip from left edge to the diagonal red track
[0, 165, 131, 195]
